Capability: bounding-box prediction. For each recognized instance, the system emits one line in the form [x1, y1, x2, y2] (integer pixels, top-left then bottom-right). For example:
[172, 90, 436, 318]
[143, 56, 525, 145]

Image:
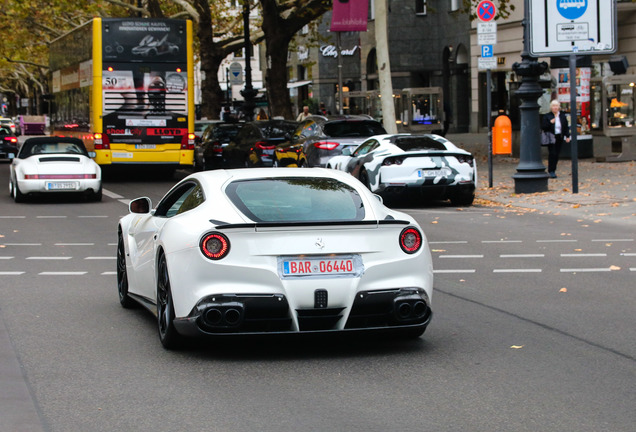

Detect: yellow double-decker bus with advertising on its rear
[49, 18, 194, 169]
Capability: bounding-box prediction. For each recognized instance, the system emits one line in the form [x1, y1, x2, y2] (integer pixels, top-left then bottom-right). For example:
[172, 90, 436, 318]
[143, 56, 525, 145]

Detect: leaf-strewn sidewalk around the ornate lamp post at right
[447, 134, 636, 226]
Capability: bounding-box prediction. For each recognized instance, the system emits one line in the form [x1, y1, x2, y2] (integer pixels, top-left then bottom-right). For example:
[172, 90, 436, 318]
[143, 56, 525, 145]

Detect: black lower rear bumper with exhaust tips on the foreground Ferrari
[174, 288, 432, 337]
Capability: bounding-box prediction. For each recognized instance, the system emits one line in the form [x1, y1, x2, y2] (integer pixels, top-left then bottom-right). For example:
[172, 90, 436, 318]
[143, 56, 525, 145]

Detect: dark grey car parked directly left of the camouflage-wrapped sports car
[291, 115, 386, 167]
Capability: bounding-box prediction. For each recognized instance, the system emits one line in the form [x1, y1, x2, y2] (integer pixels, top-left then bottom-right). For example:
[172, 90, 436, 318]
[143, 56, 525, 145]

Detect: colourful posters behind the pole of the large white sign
[552, 67, 592, 138]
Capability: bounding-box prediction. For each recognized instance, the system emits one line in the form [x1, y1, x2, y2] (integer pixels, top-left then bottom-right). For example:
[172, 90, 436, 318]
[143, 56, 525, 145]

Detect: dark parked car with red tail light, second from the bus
[223, 120, 298, 168]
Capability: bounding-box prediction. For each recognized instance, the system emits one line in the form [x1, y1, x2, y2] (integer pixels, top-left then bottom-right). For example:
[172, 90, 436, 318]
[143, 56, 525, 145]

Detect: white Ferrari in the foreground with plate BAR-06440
[117, 168, 433, 349]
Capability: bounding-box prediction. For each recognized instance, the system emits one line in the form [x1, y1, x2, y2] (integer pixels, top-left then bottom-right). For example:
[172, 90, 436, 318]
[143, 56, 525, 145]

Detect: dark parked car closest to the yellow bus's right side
[194, 122, 244, 171]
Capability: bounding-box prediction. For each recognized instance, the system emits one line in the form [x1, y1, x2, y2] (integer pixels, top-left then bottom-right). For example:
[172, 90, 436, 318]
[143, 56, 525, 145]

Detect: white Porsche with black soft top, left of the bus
[9, 137, 102, 202]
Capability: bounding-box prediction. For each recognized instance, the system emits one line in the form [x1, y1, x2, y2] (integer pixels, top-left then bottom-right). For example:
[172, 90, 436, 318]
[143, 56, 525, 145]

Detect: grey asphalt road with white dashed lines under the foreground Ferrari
[0, 164, 636, 432]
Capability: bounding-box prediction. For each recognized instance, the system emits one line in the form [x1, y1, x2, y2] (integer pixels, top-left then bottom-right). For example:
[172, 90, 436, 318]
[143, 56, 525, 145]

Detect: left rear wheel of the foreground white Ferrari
[157, 252, 181, 350]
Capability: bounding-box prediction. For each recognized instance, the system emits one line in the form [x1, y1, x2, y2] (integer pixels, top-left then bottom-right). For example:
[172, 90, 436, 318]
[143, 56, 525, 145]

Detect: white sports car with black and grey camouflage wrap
[327, 134, 477, 205]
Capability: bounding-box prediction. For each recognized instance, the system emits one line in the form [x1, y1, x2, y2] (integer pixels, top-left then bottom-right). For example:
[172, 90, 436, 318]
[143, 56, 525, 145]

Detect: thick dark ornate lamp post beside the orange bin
[512, 0, 548, 193]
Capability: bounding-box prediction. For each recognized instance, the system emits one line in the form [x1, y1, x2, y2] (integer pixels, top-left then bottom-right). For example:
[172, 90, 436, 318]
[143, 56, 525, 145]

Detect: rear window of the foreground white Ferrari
[226, 177, 364, 223]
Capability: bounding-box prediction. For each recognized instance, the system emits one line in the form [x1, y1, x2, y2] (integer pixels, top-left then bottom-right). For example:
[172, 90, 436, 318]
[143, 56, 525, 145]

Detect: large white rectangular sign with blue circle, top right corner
[528, 0, 617, 57]
